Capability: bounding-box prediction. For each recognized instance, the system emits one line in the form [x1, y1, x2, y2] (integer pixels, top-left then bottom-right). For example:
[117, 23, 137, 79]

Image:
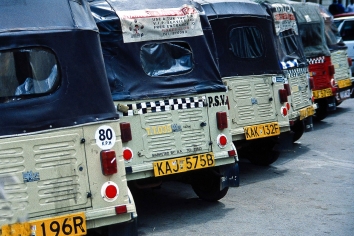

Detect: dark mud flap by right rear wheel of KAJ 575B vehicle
[220, 162, 240, 189]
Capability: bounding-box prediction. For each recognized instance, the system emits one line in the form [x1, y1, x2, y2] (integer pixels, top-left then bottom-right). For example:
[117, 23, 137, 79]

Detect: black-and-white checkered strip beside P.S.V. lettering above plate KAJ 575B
[123, 96, 205, 116]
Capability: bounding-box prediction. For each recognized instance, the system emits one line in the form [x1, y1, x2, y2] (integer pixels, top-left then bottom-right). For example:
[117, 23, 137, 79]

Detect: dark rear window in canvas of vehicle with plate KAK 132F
[229, 27, 264, 58]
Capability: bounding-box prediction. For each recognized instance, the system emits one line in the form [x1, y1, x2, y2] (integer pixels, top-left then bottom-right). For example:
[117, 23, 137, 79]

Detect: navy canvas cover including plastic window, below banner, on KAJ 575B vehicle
[89, 0, 226, 101]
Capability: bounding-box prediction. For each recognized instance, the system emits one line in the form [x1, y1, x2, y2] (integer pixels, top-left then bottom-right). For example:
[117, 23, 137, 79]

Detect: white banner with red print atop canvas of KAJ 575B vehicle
[117, 5, 203, 43]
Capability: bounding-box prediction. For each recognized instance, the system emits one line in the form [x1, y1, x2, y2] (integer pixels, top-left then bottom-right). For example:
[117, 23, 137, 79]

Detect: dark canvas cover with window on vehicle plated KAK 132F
[192, 0, 281, 77]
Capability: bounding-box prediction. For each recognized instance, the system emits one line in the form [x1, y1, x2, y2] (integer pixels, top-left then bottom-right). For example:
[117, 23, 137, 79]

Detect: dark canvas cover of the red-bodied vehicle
[288, 1, 330, 57]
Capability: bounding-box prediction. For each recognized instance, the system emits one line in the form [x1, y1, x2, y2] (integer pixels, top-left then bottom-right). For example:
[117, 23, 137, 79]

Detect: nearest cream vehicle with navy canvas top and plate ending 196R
[0, 0, 137, 236]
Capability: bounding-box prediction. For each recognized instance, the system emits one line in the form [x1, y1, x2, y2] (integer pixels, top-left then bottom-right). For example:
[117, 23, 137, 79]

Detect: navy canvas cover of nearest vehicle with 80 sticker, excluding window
[0, 0, 118, 135]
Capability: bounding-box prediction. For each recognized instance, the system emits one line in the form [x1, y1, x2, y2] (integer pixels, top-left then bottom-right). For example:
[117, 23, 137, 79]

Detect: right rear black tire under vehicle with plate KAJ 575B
[192, 171, 229, 202]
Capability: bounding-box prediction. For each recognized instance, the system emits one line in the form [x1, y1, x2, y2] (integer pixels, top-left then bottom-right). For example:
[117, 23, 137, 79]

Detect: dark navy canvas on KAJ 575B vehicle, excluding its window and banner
[89, 0, 226, 100]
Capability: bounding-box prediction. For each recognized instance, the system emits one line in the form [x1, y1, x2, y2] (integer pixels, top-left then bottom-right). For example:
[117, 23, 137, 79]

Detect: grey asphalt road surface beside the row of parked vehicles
[134, 99, 354, 236]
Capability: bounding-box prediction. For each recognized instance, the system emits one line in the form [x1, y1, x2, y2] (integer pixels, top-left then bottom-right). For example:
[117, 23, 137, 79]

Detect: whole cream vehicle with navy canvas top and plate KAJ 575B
[89, 0, 239, 201]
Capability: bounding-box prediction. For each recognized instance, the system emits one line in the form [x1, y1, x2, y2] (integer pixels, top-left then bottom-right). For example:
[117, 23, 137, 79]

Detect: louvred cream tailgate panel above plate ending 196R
[0, 128, 91, 225]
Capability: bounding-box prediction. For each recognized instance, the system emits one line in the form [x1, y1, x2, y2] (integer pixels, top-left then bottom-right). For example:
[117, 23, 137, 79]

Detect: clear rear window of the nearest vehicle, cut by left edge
[0, 48, 59, 102]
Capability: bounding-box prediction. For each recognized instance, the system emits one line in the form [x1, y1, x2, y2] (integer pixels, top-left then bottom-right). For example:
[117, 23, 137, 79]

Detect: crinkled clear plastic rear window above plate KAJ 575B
[140, 42, 193, 77]
